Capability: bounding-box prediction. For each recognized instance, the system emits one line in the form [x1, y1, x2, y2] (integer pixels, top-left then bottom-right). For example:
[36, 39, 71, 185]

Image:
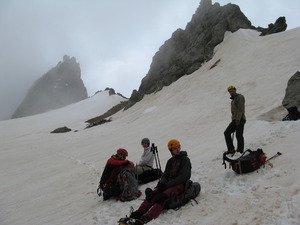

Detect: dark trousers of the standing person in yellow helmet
[224, 120, 246, 153]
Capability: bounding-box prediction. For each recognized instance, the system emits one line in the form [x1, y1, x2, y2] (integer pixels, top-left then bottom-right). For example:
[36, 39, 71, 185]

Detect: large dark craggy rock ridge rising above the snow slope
[127, 0, 254, 108]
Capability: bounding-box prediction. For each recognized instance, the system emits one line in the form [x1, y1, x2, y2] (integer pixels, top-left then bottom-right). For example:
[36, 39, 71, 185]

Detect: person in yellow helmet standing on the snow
[224, 85, 246, 154]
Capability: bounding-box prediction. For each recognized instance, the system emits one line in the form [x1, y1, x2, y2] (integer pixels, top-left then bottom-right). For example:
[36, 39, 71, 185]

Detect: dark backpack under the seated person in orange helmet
[165, 180, 201, 209]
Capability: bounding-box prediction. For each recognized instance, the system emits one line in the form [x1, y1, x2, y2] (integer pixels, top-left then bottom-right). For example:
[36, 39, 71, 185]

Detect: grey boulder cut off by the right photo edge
[282, 71, 300, 108]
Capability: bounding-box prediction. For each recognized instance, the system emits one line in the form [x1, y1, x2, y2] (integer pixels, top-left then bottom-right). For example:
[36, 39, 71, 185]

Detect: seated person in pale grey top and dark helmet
[136, 138, 154, 175]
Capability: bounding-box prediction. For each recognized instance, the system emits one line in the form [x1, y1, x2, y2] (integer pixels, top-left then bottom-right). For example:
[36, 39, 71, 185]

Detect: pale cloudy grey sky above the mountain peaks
[0, 0, 300, 120]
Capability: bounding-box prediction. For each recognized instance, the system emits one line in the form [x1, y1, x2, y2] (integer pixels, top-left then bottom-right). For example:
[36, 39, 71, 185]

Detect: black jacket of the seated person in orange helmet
[159, 151, 192, 188]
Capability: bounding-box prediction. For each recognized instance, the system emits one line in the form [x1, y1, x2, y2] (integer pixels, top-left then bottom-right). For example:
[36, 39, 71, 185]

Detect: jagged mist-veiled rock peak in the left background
[12, 55, 88, 118]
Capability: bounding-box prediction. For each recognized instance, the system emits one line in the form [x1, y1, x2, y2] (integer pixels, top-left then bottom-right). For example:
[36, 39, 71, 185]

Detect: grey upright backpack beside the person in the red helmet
[117, 168, 140, 202]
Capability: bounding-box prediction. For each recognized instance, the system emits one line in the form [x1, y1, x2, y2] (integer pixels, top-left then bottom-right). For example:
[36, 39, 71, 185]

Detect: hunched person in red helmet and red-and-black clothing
[99, 148, 134, 200]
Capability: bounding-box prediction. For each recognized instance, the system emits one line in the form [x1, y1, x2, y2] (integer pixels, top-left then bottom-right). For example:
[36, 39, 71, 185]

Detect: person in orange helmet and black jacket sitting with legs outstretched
[129, 139, 192, 225]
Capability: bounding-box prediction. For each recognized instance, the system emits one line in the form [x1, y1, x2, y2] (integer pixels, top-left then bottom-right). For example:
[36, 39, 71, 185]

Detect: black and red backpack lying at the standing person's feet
[223, 148, 266, 174]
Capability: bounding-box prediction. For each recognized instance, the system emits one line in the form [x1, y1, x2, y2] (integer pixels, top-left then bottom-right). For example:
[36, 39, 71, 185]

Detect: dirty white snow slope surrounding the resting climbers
[0, 28, 300, 225]
